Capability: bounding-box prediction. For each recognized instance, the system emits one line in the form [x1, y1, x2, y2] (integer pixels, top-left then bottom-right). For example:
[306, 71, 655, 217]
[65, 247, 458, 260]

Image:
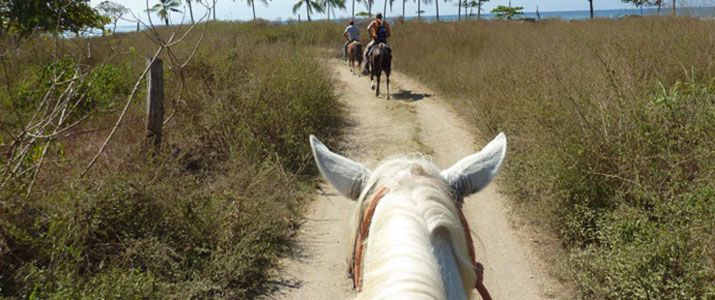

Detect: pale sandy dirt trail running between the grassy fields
[267, 60, 561, 300]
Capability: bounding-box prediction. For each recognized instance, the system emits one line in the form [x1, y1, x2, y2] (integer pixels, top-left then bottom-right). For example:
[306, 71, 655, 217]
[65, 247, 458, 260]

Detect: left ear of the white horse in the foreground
[310, 135, 370, 200]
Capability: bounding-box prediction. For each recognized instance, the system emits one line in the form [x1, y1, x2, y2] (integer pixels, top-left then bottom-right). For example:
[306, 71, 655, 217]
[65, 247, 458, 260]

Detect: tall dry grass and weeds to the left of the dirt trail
[0, 23, 342, 299]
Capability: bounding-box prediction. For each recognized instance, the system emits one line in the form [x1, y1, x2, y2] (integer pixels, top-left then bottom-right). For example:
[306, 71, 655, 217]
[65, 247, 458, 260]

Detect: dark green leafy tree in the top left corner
[0, 0, 111, 36]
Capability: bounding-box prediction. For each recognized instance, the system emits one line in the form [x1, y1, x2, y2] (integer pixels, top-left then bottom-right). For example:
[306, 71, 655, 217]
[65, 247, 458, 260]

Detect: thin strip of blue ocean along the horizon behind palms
[107, 7, 715, 32]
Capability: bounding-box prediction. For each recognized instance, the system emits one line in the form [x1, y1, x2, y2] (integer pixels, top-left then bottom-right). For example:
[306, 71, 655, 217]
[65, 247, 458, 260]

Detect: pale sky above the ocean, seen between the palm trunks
[91, 0, 688, 25]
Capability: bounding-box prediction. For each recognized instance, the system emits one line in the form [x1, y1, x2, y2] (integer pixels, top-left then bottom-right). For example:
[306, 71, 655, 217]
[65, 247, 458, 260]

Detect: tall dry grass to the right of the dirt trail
[391, 17, 715, 299]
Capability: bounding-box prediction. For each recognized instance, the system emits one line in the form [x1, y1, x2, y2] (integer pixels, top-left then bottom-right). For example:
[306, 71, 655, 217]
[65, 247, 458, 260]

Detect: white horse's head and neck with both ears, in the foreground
[310, 133, 506, 299]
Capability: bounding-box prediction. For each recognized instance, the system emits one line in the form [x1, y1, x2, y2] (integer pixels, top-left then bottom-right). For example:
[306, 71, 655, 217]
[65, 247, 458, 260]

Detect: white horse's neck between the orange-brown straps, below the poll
[358, 188, 471, 300]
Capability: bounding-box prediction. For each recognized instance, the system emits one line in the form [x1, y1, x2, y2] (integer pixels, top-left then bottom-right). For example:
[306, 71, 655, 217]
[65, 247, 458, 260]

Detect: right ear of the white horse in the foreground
[441, 132, 506, 197]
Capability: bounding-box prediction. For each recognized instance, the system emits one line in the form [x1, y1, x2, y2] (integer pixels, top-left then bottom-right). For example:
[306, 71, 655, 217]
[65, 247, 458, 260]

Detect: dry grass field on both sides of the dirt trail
[0, 17, 715, 299]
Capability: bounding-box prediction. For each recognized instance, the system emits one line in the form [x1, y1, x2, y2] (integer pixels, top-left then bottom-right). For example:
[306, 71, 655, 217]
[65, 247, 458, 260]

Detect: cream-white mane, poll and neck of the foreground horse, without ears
[351, 156, 476, 299]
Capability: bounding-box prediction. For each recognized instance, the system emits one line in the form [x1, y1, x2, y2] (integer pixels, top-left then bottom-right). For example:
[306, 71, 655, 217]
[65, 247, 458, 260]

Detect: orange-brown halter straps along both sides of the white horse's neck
[351, 175, 492, 300]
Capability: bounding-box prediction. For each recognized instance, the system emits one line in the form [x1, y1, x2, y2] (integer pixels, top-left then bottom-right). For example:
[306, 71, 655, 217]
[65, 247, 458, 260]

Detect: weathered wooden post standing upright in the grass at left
[146, 57, 164, 152]
